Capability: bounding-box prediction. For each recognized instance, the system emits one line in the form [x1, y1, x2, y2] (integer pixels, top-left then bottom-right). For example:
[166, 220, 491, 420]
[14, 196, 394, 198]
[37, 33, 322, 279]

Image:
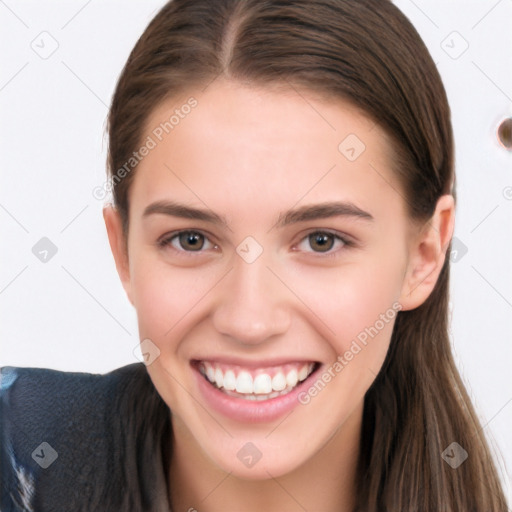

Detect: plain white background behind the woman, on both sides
[0, 0, 512, 504]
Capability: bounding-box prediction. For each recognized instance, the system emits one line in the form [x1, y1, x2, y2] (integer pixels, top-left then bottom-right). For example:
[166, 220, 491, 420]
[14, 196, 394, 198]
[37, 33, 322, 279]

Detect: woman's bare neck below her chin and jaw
[169, 404, 363, 512]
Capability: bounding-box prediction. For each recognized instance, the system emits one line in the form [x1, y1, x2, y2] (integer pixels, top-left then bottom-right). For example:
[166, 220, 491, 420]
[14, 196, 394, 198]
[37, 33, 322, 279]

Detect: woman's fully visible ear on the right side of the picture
[400, 194, 455, 311]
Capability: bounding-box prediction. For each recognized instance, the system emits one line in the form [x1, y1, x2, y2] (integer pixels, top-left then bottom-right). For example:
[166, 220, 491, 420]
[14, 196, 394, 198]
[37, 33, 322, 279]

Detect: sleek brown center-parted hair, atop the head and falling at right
[108, 0, 507, 512]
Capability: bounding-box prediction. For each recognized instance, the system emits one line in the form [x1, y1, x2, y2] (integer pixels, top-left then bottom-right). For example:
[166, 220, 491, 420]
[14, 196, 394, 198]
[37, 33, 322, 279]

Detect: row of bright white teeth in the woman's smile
[199, 361, 314, 400]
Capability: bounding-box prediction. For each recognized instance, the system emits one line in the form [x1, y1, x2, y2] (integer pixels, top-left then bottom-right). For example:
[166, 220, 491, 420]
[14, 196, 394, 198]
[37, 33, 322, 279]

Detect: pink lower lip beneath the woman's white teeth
[192, 366, 318, 423]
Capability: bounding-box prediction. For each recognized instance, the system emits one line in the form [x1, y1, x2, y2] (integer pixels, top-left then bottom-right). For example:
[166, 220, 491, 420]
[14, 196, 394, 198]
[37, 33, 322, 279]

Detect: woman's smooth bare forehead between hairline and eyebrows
[130, 80, 406, 226]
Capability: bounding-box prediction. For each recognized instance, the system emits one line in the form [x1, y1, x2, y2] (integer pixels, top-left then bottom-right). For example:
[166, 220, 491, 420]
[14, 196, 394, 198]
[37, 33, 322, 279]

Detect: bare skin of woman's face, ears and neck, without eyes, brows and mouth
[104, 80, 454, 512]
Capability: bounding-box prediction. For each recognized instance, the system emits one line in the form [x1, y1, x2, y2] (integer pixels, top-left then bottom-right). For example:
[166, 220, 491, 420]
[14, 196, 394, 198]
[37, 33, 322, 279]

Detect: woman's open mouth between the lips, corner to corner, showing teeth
[193, 361, 320, 401]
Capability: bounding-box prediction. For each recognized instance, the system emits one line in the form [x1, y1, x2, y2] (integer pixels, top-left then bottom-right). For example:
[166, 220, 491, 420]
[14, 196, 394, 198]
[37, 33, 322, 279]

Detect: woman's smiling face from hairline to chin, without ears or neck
[111, 80, 420, 479]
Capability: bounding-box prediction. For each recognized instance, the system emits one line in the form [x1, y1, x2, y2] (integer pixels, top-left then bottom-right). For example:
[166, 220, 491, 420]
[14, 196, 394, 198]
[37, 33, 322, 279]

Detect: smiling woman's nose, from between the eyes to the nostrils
[213, 254, 291, 345]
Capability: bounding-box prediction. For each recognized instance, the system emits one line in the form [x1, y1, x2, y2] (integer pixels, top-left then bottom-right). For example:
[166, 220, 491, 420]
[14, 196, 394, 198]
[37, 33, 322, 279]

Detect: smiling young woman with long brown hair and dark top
[2, 0, 507, 512]
